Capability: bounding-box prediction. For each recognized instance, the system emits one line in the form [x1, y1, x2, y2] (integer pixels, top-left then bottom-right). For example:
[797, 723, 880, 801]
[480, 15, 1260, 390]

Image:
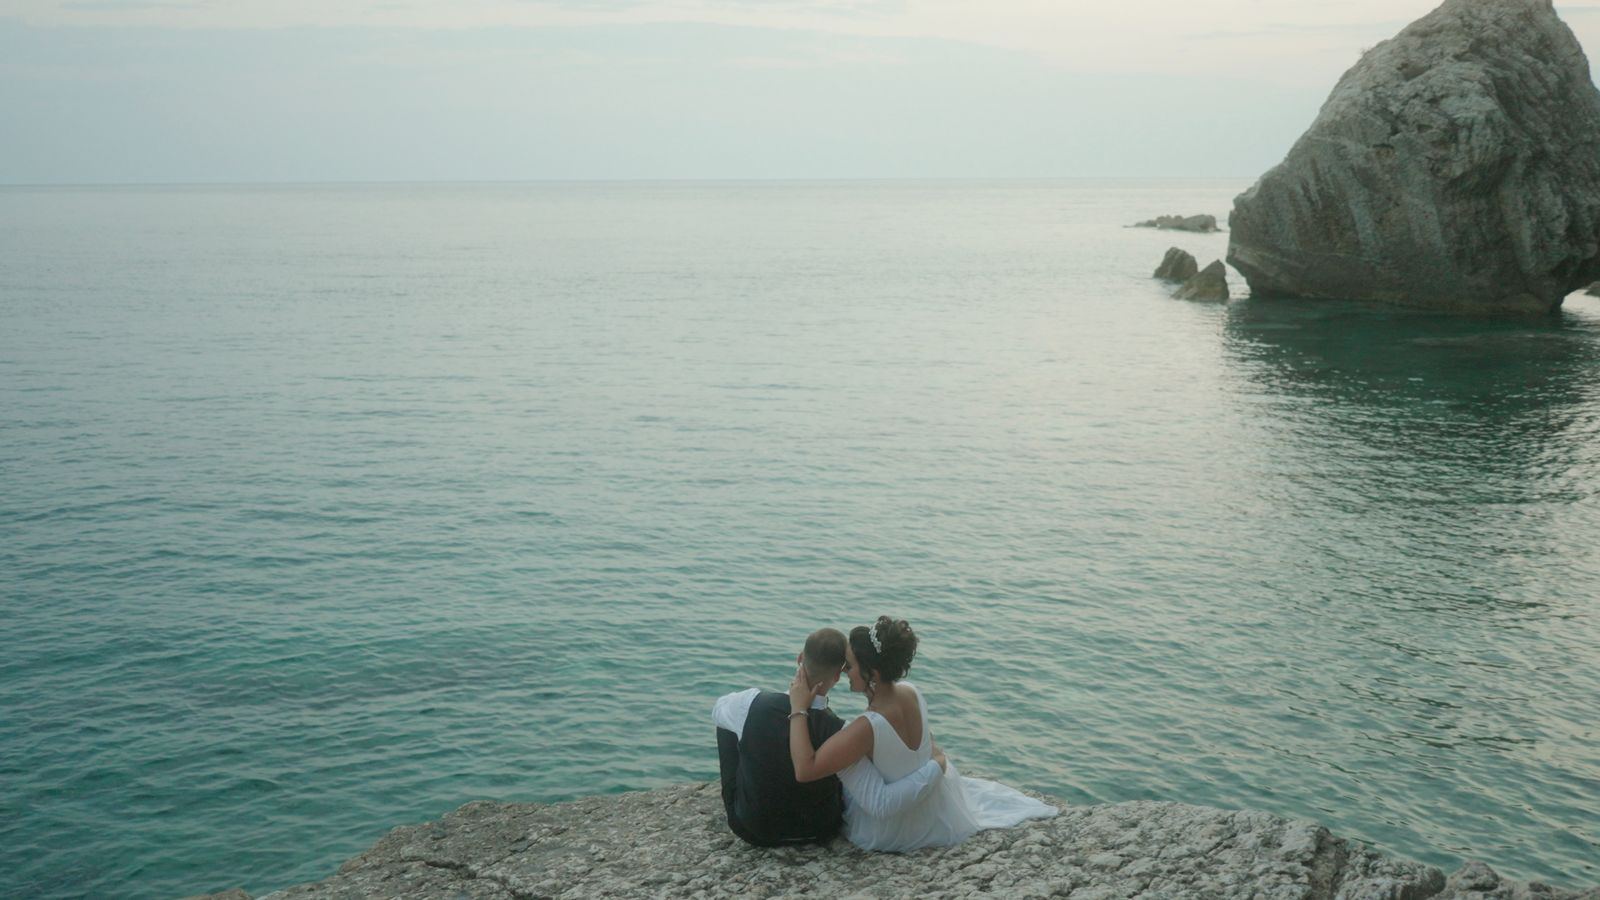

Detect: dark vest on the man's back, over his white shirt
[717, 690, 845, 847]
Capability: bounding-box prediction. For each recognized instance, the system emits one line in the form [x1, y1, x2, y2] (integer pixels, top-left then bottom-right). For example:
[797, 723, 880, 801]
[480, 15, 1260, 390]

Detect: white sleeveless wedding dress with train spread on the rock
[845, 681, 1059, 850]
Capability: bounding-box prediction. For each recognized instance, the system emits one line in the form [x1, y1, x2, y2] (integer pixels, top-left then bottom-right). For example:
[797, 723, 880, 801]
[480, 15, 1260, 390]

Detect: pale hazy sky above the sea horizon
[9, 0, 1600, 184]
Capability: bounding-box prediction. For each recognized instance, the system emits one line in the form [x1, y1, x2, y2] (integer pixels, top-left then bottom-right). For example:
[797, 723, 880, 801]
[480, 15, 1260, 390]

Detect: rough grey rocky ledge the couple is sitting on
[184, 783, 1600, 900]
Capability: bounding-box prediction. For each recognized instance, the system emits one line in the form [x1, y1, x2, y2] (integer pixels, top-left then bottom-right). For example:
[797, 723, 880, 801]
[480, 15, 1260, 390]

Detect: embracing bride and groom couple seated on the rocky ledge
[712, 617, 1056, 850]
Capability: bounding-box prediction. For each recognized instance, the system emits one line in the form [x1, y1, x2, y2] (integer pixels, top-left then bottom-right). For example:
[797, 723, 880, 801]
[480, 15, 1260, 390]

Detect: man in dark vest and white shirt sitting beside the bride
[712, 628, 942, 847]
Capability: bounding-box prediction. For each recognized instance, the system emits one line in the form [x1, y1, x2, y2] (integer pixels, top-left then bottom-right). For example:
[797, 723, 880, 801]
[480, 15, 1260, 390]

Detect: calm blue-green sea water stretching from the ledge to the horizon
[0, 181, 1600, 897]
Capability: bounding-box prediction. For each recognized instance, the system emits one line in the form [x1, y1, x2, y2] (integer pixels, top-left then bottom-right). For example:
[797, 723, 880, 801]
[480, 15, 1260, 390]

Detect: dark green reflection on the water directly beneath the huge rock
[1227, 301, 1600, 474]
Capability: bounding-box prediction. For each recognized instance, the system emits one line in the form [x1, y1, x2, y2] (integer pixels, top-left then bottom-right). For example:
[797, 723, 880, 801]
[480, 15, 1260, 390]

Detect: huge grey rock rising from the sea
[1227, 0, 1600, 312]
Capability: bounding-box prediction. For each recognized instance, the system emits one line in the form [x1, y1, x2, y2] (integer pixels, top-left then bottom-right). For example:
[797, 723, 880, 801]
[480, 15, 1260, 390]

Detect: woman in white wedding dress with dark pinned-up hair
[789, 617, 1058, 850]
